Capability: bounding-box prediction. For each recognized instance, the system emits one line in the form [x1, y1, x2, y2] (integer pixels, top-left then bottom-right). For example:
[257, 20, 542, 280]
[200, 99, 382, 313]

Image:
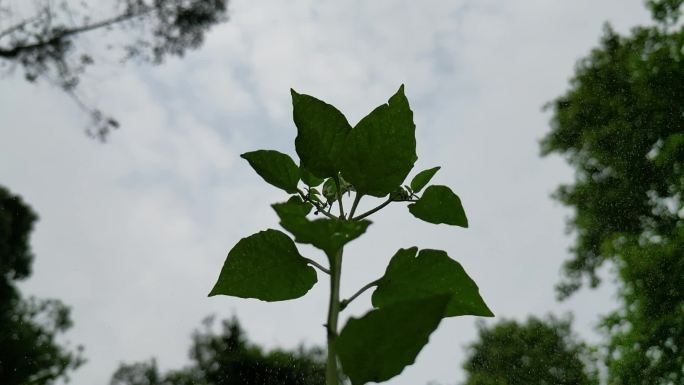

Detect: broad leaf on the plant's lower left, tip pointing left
[209, 229, 318, 302]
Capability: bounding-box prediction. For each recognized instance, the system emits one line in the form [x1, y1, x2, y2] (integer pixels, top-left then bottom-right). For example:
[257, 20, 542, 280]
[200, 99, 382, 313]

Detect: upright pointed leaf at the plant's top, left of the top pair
[291, 90, 351, 178]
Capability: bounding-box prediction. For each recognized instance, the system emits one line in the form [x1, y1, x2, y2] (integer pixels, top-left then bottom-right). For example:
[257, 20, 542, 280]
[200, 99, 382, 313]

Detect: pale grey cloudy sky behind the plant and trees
[0, 0, 648, 385]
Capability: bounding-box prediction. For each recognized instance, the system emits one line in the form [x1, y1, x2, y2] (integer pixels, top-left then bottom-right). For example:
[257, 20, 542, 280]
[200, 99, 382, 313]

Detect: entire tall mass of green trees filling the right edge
[541, 0, 684, 385]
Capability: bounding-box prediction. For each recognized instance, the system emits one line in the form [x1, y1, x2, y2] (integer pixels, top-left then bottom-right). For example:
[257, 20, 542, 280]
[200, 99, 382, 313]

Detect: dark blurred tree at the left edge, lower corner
[0, 186, 83, 385]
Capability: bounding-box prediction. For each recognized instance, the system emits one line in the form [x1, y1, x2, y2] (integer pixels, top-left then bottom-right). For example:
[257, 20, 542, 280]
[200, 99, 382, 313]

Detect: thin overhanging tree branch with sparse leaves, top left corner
[0, 0, 227, 139]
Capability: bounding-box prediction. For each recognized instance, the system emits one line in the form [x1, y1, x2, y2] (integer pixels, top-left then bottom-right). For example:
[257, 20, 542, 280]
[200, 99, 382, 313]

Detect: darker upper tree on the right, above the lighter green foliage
[542, 20, 684, 295]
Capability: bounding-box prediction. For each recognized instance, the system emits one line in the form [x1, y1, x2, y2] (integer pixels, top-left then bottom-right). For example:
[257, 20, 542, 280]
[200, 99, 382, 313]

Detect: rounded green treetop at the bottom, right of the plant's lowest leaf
[463, 317, 598, 385]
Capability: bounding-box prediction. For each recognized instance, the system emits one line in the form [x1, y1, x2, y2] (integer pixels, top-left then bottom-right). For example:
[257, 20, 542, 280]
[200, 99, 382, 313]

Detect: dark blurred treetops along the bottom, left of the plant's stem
[110, 318, 325, 385]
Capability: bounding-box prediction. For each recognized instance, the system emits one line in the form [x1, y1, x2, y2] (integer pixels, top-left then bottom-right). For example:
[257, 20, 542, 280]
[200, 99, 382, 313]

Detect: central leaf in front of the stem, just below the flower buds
[272, 197, 371, 256]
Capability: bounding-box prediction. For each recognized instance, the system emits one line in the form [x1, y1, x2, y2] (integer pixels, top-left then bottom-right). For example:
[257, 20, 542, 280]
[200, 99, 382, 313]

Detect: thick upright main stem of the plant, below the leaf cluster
[325, 248, 344, 385]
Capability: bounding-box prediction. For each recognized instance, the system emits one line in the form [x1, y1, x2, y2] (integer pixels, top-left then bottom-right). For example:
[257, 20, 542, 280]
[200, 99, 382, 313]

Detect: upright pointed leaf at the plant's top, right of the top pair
[341, 85, 418, 197]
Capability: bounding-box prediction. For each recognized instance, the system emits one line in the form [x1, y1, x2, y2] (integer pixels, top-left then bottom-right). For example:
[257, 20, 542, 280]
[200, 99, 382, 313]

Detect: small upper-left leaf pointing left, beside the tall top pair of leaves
[240, 150, 299, 194]
